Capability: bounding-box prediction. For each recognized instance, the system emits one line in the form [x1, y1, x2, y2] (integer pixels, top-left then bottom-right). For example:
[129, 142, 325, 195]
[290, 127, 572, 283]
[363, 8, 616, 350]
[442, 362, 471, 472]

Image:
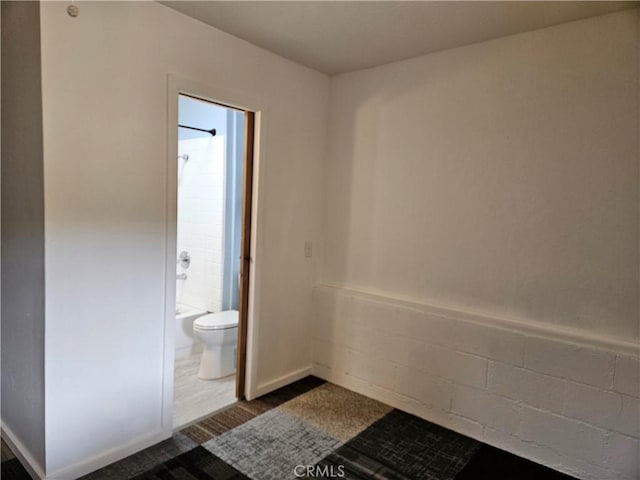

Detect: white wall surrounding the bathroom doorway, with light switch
[41, 2, 328, 478]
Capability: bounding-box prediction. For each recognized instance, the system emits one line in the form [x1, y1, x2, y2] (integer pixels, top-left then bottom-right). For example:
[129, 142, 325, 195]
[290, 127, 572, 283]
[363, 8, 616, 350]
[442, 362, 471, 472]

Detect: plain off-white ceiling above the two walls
[160, 1, 639, 75]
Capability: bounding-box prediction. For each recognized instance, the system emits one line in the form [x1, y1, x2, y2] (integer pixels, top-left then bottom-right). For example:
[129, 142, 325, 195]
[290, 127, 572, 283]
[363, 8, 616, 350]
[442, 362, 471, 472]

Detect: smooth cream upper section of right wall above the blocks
[322, 10, 640, 340]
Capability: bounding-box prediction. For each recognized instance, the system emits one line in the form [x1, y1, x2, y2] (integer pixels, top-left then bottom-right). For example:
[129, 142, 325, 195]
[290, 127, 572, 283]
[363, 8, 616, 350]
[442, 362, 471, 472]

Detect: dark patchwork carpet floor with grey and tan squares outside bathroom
[2, 377, 571, 480]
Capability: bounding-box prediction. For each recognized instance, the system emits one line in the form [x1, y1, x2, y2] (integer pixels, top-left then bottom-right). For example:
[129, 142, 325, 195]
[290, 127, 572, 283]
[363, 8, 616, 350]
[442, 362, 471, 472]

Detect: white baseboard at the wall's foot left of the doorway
[43, 430, 171, 480]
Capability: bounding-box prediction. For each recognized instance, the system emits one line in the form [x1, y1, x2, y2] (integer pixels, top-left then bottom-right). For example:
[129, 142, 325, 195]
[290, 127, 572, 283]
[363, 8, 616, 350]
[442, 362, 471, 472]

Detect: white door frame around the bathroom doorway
[161, 74, 268, 437]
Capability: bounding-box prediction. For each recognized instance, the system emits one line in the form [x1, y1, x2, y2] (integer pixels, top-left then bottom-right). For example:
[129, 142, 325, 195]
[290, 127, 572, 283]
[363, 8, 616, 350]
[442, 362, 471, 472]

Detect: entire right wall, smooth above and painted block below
[313, 9, 640, 480]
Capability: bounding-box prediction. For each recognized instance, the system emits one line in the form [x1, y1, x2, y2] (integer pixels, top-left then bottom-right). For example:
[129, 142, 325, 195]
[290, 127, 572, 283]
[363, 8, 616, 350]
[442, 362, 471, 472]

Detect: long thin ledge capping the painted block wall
[315, 283, 640, 355]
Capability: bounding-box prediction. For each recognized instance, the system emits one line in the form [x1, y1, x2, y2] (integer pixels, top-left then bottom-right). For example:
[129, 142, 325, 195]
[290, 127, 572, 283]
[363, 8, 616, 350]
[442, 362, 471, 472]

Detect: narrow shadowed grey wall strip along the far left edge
[1, 2, 45, 470]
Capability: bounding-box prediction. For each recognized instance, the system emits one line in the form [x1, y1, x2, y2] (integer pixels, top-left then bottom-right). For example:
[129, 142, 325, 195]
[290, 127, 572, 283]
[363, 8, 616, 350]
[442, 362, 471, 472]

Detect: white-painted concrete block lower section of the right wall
[312, 286, 640, 480]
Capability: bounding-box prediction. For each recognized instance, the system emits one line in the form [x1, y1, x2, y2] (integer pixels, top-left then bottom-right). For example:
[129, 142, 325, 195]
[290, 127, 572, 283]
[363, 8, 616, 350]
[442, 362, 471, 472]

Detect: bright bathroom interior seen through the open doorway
[173, 95, 244, 429]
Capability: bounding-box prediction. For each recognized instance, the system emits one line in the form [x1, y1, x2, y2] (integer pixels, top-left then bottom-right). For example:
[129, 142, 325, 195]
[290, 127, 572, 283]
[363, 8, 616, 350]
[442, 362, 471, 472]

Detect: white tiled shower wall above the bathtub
[176, 137, 224, 311]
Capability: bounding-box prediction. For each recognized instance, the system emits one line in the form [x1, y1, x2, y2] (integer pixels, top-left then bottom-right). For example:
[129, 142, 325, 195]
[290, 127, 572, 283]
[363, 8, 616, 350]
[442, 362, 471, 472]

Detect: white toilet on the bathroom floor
[193, 310, 238, 380]
